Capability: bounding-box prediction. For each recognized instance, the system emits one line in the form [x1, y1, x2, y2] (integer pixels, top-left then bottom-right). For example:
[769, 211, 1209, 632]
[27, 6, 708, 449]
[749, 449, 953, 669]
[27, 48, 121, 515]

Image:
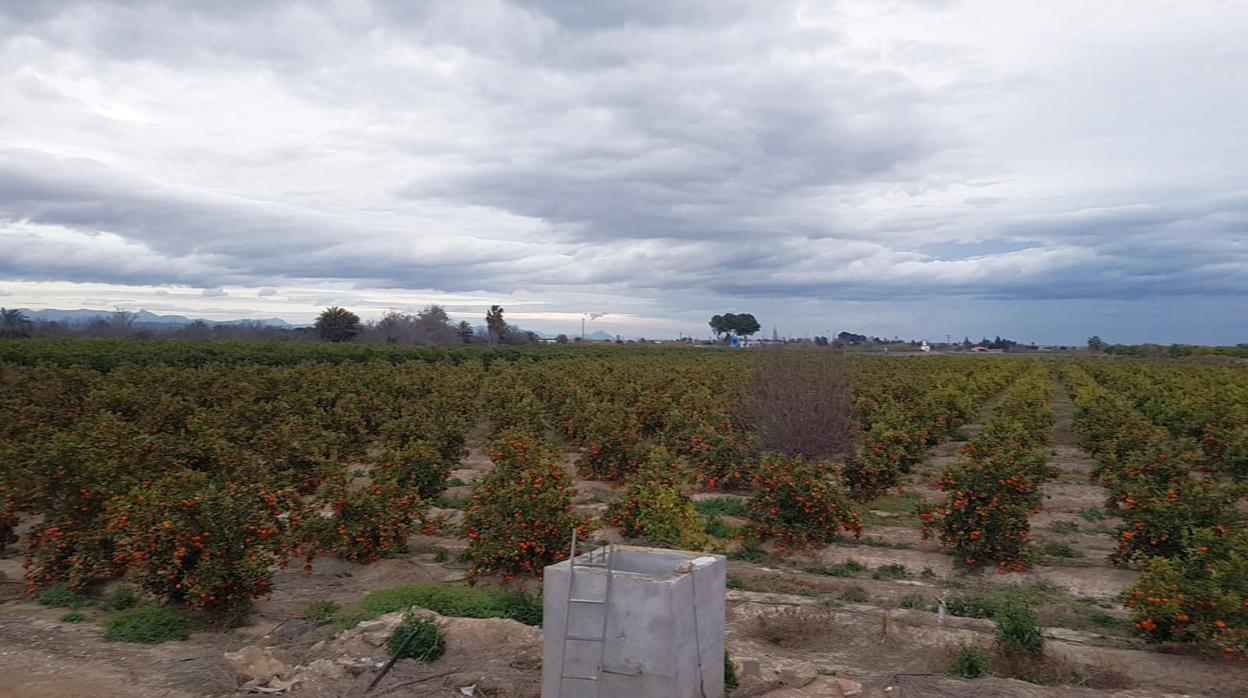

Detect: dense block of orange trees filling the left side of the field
[0, 362, 482, 622]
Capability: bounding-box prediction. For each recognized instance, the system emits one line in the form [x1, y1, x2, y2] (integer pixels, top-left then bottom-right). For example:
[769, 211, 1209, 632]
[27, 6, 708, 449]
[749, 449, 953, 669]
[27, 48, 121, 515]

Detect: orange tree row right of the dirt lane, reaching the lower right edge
[1063, 362, 1248, 659]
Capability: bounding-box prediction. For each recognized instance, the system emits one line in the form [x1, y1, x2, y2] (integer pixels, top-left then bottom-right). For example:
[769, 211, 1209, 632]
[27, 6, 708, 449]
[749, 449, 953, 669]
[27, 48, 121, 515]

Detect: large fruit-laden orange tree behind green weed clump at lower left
[107, 471, 300, 623]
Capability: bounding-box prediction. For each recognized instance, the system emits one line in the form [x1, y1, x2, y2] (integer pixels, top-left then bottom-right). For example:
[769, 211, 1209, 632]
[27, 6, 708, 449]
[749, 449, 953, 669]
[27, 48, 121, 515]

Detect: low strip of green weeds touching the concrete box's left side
[359, 582, 542, 626]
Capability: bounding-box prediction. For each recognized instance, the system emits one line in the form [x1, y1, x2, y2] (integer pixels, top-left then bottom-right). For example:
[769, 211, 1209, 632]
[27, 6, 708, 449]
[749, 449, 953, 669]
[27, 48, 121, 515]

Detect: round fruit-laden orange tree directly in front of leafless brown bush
[749, 453, 862, 551]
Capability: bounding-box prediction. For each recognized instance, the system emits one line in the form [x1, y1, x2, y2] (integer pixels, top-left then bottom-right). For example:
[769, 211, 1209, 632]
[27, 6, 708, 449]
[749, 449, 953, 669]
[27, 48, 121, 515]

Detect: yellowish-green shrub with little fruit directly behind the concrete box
[607, 446, 706, 548]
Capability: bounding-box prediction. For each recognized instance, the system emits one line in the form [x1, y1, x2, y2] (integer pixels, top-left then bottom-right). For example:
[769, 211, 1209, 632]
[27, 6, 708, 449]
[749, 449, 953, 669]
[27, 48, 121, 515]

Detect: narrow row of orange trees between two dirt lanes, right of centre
[920, 366, 1056, 572]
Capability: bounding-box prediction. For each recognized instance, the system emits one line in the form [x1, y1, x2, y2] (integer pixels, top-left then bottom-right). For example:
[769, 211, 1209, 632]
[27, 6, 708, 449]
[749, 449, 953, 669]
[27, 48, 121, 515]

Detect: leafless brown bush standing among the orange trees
[749, 348, 852, 458]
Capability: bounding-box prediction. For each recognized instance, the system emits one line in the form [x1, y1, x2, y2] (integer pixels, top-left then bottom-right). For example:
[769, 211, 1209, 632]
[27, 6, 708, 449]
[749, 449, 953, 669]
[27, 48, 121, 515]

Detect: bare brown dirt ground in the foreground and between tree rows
[0, 386, 1248, 698]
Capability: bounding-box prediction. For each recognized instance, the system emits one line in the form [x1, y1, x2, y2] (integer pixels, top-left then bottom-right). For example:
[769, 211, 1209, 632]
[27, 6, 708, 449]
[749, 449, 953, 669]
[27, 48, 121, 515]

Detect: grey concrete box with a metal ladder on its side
[542, 546, 728, 698]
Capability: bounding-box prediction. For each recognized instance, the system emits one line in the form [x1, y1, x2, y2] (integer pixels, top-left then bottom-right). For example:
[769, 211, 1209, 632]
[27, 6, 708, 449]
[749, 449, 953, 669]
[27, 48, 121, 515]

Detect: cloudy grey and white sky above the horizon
[0, 0, 1248, 342]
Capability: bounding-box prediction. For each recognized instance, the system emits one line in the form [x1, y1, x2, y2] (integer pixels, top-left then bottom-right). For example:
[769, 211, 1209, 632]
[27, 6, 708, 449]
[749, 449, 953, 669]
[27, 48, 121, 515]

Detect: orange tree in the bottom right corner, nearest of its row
[1123, 527, 1248, 659]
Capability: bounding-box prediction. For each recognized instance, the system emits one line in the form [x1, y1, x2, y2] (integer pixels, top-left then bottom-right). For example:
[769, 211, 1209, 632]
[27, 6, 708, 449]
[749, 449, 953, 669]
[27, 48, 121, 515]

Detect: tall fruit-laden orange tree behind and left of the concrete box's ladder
[463, 430, 588, 581]
